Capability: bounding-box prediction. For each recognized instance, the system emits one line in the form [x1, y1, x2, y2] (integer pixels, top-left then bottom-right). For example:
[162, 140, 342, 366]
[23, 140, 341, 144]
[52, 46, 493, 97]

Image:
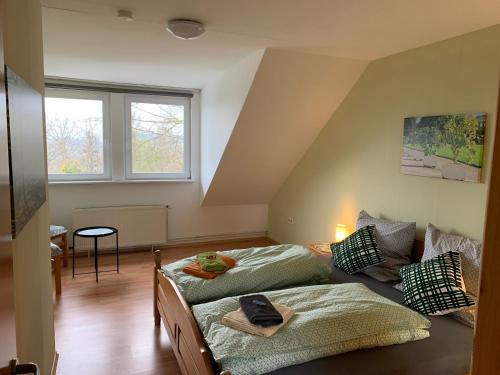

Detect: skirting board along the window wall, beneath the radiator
[70, 232, 275, 256]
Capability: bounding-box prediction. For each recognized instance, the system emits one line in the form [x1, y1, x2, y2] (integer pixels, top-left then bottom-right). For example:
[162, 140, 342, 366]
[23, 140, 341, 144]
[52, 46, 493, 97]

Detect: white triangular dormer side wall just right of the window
[201, 50, 264, 194]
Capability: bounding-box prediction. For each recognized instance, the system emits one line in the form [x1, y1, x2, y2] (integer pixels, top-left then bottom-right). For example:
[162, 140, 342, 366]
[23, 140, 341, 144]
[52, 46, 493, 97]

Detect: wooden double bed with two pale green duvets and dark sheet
[154, 242, 472, 375]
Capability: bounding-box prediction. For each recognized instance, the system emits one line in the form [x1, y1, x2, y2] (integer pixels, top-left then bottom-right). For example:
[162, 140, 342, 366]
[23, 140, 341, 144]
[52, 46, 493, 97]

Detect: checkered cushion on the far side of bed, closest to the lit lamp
[330, 225, 384, 274]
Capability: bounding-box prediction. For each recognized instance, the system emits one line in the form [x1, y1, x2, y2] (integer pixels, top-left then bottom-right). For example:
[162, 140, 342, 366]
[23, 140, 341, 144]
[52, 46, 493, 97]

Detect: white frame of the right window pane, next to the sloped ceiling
[124, 94, 191, 181]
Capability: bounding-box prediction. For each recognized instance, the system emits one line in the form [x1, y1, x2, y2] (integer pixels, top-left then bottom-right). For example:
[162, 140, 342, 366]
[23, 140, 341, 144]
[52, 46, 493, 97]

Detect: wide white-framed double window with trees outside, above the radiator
[45, 85, 192, 182]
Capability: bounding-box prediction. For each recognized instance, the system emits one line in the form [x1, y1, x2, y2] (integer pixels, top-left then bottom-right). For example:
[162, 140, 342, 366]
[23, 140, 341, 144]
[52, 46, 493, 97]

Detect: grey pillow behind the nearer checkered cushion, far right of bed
[422, 224, 482, 327]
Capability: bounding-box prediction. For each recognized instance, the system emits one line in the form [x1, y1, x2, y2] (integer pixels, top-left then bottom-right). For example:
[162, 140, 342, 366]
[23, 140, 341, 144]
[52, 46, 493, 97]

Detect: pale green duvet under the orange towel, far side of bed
[162, 245, 331, 304]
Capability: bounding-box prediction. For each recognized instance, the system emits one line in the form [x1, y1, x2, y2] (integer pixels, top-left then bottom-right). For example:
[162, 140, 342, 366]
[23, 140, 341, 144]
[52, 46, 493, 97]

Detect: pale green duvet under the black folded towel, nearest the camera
[192, 283, 431, 375]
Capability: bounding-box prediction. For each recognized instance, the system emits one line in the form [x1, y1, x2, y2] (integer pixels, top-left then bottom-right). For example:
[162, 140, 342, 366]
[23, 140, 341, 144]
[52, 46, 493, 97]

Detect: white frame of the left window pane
[44, 88, 112, 182]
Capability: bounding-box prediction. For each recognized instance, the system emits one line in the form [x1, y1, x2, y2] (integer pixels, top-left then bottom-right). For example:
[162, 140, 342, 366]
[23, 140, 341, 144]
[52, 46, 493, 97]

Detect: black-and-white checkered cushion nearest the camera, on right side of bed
[399, 251, 474, 315]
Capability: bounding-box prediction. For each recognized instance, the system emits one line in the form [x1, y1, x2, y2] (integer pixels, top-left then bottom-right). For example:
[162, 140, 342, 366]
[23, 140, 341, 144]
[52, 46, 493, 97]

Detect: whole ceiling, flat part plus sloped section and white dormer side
[42, 0, 500, 205]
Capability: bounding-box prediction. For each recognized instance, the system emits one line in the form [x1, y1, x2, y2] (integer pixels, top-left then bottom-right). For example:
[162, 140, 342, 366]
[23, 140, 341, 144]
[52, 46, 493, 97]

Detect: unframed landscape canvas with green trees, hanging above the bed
[401, 112, 486, 182]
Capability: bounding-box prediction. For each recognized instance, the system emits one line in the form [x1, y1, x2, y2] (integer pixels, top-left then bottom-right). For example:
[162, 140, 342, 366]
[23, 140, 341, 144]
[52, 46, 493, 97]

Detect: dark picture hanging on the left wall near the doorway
[5, 67, 47, 238]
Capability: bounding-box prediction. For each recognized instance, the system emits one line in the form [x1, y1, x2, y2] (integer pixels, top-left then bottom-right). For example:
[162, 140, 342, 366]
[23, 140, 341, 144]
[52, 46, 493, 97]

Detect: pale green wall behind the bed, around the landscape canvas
[269, 25, 500, 244]
